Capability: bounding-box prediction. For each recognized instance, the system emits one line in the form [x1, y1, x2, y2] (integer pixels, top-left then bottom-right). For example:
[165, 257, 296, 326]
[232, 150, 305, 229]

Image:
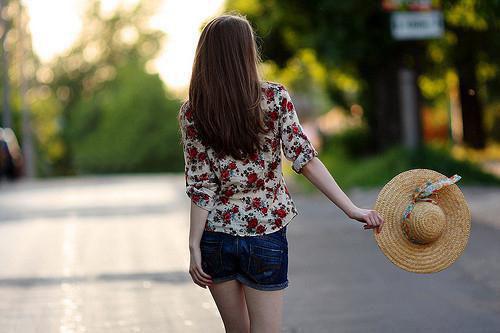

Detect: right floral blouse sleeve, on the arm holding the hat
[279, 88, 318, 174]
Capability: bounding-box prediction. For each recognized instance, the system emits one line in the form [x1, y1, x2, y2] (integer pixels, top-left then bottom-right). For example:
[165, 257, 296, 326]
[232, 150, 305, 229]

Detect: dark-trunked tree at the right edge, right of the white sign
[443, 0, 500, 148]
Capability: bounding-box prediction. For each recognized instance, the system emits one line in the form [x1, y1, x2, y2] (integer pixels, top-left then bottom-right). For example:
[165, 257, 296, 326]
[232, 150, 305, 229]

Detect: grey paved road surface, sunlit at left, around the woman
[0, 175, 500, 333]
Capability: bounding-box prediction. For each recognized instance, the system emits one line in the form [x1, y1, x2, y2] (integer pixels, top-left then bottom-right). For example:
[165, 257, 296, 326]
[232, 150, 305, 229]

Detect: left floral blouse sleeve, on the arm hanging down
[180, 106, 219, 211]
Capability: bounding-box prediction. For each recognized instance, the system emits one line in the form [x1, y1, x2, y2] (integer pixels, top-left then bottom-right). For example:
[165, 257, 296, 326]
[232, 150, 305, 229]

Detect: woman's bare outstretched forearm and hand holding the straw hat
[300, 157, 384, 232]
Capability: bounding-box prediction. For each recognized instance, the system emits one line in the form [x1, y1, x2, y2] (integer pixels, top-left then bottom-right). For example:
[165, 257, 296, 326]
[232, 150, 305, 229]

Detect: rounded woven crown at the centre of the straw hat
[408, 202, 446, 244]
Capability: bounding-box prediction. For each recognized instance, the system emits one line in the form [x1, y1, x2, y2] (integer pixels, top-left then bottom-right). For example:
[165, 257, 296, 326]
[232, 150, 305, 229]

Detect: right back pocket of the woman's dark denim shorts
[248, 242, 287, 284]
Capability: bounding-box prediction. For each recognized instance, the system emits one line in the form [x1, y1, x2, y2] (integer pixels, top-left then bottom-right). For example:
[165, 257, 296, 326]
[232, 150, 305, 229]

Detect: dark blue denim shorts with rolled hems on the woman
[200, 226, 288, 290]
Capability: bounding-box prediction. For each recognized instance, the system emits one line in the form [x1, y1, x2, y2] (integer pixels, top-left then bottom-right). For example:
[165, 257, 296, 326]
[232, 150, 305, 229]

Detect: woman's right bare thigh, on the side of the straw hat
[243, 285, 284, 333]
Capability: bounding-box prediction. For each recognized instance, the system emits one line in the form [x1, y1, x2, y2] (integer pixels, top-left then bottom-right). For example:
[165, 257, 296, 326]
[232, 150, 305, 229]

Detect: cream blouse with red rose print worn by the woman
[180, 81, 318, 236]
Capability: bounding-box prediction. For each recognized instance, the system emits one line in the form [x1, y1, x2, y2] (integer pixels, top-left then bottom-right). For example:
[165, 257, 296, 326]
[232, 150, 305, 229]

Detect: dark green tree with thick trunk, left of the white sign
[228, 0, 423, 148]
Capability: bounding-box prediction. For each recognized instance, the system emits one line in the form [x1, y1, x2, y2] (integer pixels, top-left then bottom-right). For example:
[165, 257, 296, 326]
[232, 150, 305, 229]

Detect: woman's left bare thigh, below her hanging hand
[209, 280, 250, 333]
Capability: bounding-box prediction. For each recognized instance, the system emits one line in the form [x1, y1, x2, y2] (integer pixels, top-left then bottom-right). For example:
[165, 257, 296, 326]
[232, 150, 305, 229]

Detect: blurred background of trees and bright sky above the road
[1, 0, 500, 187]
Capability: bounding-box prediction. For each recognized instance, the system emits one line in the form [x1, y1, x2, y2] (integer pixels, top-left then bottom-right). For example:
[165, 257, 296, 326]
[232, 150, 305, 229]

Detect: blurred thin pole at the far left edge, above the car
[0, 0, 12, 128]
